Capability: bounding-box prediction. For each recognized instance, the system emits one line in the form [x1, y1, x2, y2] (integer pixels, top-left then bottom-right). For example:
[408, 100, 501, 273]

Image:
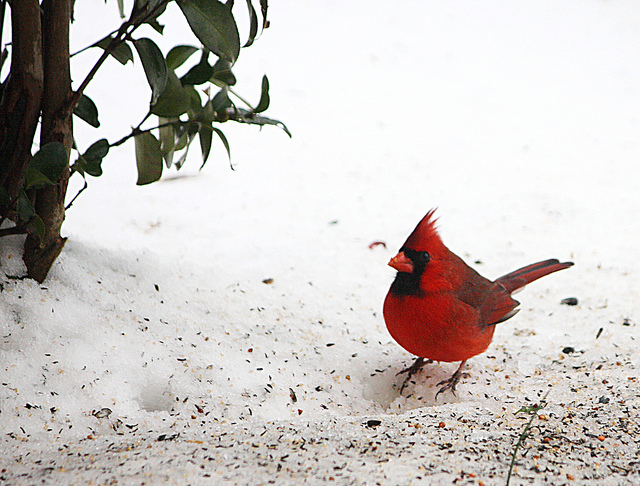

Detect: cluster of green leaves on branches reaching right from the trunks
[65, 0, 291, 190]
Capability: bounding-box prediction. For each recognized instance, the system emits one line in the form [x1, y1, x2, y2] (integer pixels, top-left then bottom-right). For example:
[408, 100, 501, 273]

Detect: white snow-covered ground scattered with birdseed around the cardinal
[0, 0, 640, 485]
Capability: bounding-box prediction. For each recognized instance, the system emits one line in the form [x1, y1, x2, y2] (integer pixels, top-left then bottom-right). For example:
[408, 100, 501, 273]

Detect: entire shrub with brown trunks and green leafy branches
[0, 0, 291, 282]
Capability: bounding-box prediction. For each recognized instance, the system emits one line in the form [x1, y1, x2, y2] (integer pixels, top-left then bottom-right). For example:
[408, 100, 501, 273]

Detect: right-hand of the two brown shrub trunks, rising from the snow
[23, 0, 73, 282]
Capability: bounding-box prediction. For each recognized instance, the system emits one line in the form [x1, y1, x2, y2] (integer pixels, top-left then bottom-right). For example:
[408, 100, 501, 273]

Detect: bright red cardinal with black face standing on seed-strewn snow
[383, 209, 573, 398]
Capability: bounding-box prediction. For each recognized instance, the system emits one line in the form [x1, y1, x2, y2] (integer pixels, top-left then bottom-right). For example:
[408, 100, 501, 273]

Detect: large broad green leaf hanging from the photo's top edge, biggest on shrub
[178, 0, 240, 64]
